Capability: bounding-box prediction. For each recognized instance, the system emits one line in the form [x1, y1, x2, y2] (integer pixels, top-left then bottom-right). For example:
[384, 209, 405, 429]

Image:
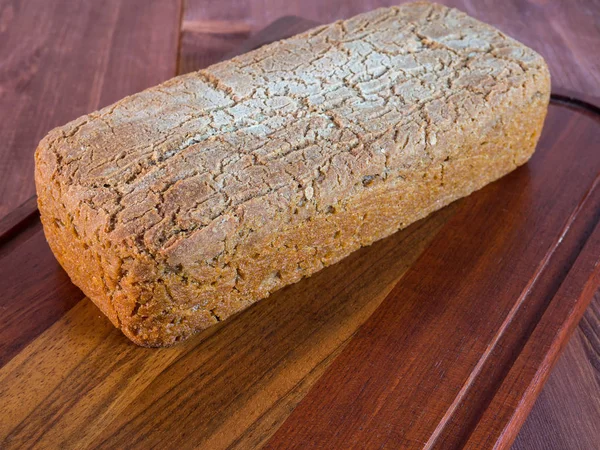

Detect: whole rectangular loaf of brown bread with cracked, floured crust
[36, 3, 550, 346]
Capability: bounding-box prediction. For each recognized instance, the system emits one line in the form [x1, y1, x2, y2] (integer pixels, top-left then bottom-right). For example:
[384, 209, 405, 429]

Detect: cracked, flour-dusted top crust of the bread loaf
[37, 3, 548, 264]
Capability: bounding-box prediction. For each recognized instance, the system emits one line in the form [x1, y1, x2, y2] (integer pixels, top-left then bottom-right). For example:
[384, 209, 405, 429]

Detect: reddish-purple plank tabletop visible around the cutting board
[0, 0, 600, 449]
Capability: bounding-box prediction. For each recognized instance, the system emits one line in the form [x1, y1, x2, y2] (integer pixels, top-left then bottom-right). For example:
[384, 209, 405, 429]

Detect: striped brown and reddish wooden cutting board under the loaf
[0, 18, 600, 449]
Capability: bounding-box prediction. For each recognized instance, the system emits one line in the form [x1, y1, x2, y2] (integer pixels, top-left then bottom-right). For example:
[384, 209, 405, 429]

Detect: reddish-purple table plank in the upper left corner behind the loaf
[0, 0, 180, 218]
